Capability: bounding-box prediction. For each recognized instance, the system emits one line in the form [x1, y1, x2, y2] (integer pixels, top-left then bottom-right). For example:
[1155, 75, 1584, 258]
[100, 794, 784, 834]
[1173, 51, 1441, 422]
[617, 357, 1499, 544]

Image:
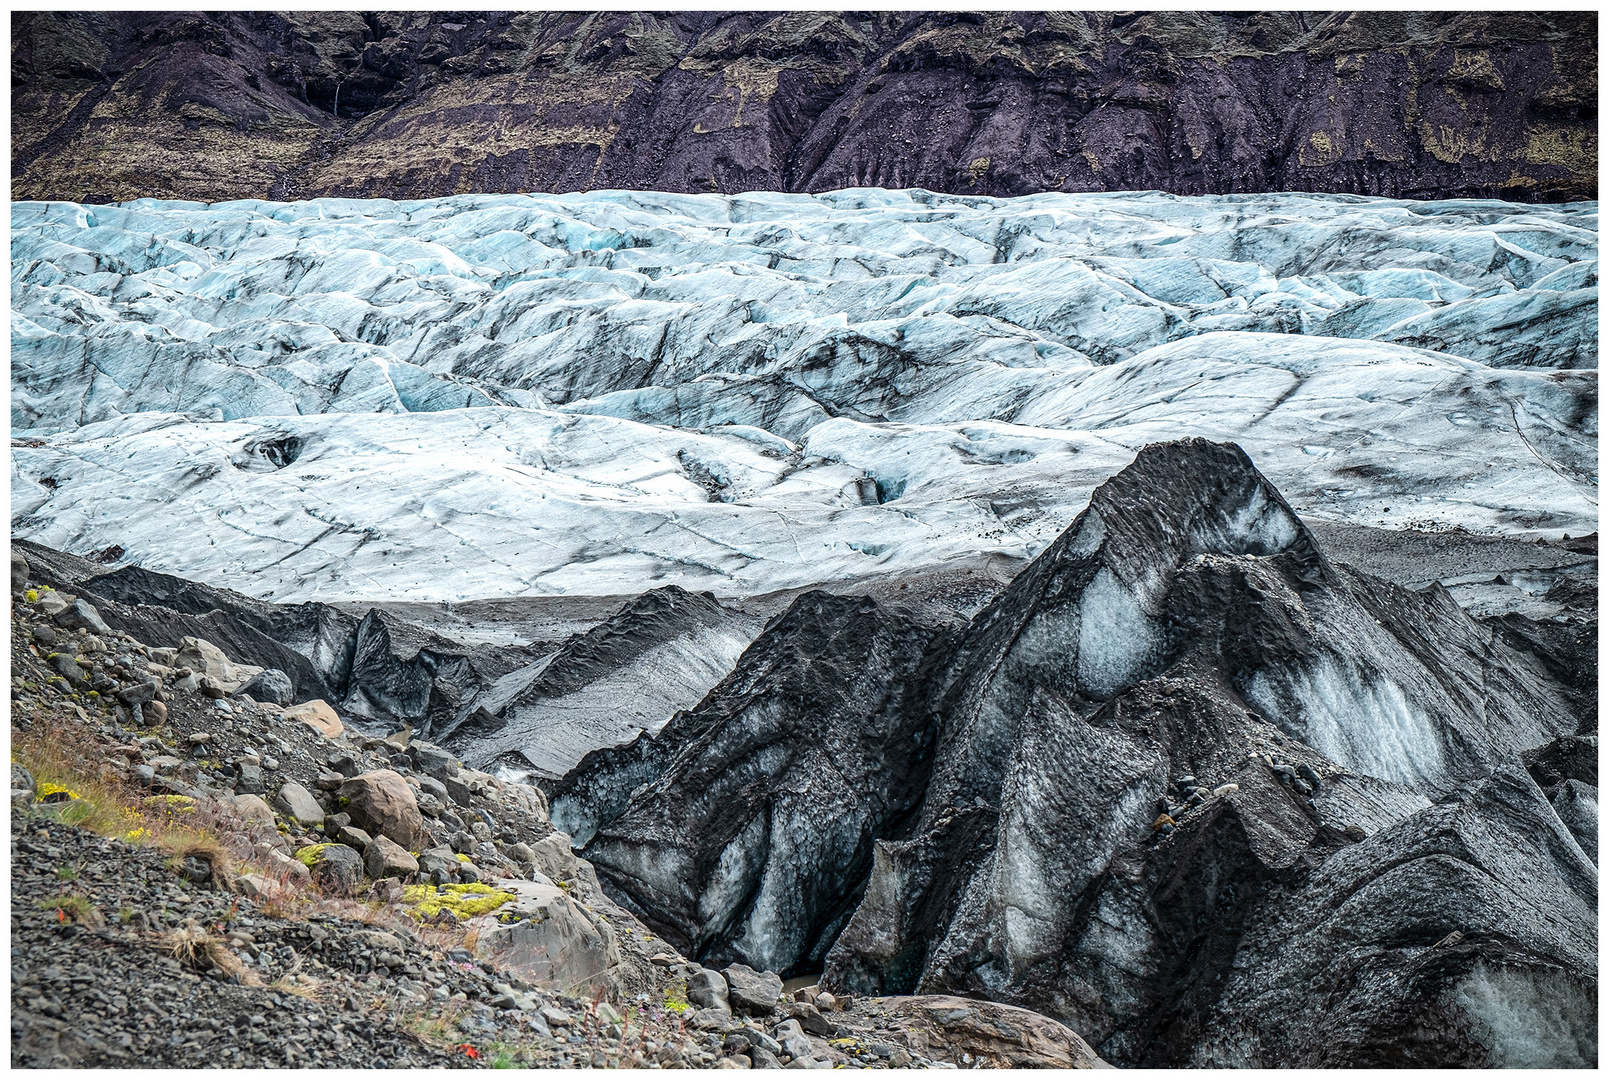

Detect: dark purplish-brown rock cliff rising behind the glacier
[11, 11, 1598, 201]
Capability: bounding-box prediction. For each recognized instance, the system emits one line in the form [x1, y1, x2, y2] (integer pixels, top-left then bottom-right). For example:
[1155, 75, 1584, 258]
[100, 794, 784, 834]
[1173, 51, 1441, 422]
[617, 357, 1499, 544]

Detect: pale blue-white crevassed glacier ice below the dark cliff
[11, 190, 1598, 599]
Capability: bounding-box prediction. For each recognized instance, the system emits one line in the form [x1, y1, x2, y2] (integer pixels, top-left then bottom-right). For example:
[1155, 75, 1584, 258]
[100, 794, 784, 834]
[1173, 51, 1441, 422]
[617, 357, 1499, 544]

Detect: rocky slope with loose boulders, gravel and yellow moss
[11, 555, 1099, 1069]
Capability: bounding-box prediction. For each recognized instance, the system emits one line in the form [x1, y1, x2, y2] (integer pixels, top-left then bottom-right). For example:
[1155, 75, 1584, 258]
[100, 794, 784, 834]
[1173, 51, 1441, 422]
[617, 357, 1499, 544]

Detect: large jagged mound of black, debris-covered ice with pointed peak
[572, 439, 1596, 1067]
